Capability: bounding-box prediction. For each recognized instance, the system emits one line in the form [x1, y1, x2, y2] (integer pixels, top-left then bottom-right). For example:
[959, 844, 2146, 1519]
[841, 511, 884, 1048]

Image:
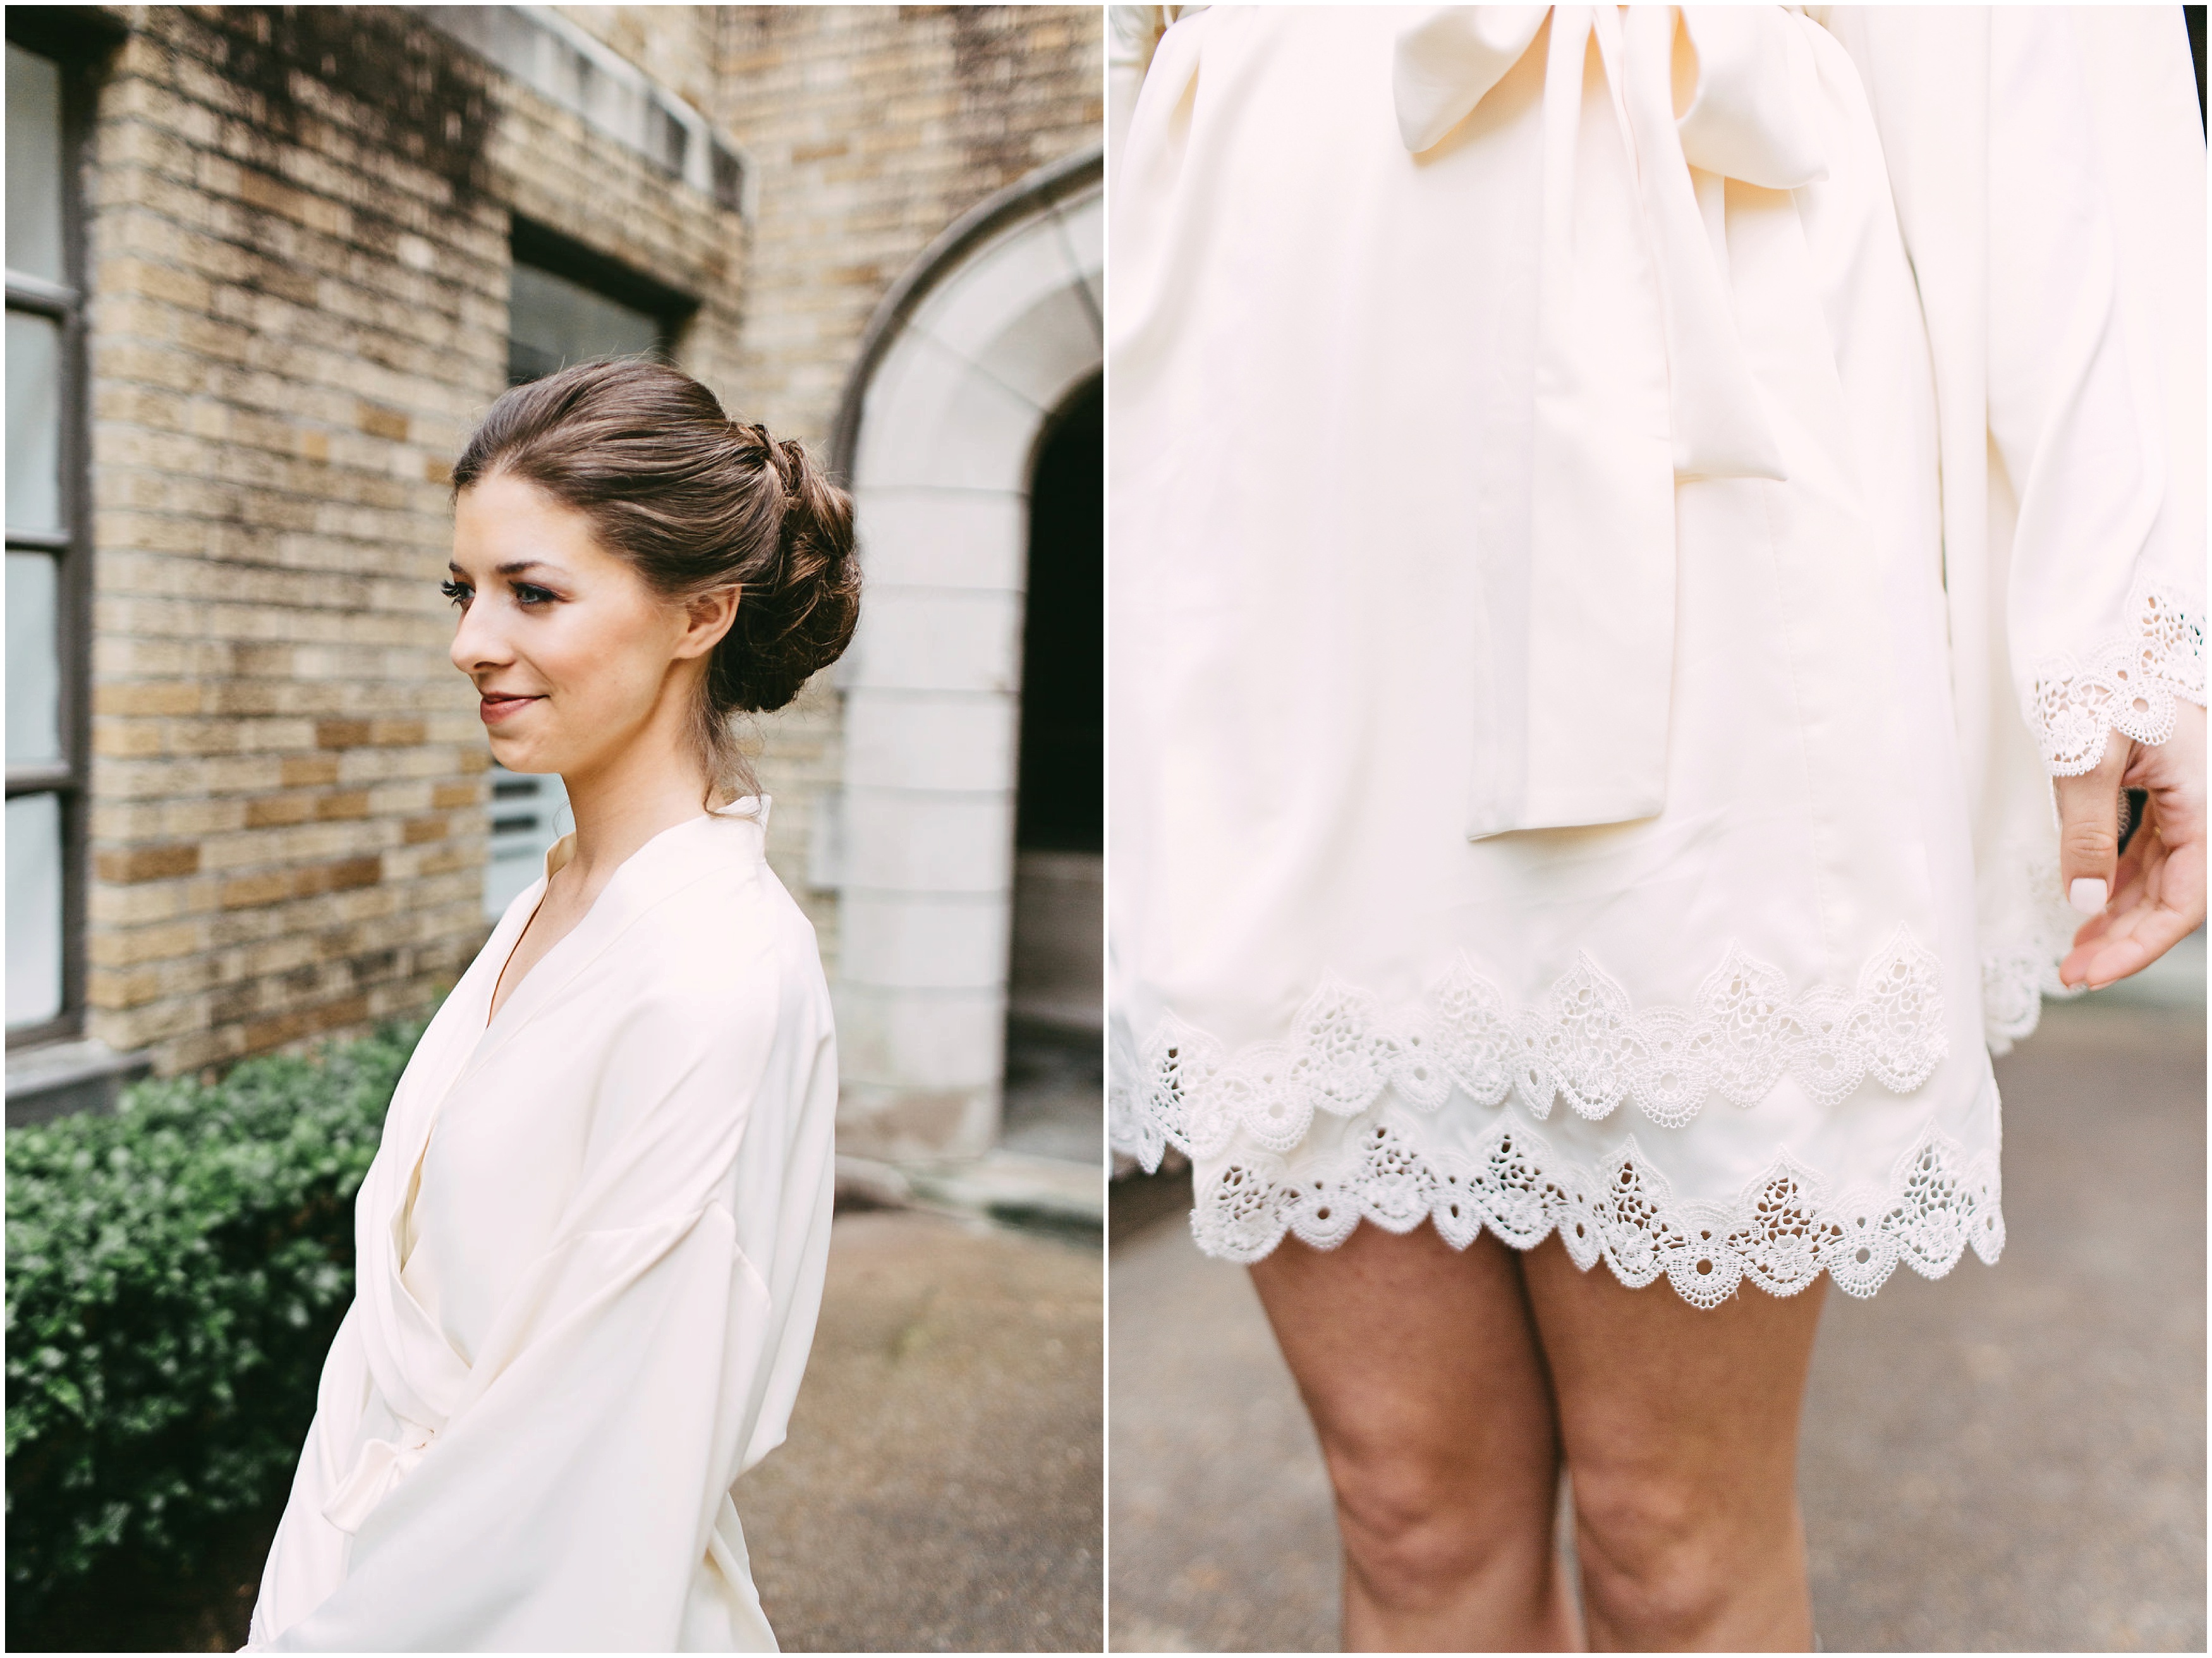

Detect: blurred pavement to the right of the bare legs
[1799, 1005, 2206, 1651]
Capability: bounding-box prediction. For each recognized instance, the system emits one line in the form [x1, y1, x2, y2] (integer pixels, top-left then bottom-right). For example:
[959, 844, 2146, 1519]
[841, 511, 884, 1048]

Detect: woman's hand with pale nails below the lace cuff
[2053, 700, 2206, 989]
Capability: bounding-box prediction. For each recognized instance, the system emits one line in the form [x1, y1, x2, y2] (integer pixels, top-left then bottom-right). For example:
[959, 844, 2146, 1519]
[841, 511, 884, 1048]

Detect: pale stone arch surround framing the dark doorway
[832, 150, 1104, 1162]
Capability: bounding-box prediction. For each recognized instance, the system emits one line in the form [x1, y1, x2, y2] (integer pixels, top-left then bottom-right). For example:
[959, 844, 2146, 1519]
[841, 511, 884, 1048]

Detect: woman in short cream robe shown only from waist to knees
[1109, 4, 2206, 1649]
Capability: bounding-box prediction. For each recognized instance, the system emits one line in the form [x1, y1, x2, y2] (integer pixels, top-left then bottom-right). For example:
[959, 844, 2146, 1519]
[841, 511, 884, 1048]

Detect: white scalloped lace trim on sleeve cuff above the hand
[2026, 580, 2206, 777]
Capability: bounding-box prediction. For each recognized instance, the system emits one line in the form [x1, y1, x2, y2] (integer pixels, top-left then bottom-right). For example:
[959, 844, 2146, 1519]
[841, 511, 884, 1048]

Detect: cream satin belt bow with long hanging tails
[1392, 4, 1827, 837]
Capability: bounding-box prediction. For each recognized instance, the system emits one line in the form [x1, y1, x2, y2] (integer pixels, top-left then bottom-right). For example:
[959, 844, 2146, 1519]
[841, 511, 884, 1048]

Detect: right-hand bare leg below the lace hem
[1522, 1238, 1827, 1651]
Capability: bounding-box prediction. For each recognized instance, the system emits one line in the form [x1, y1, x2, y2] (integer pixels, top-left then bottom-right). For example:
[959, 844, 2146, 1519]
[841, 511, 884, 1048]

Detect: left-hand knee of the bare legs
[1330, 1446, 1548, 1609]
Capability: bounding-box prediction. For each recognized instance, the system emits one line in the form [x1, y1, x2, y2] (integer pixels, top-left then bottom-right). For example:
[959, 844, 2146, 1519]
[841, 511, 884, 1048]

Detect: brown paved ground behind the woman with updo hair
[737, 1211, 1104, 1651]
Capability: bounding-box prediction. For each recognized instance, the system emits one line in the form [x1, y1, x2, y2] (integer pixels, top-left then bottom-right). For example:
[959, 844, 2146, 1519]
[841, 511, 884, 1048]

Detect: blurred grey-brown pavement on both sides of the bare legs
[1110, 991, 2206, 1651]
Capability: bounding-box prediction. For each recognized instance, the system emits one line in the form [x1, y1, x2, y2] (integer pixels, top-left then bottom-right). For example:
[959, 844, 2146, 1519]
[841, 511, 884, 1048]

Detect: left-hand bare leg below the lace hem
[1252, 1224, 1579, 1651]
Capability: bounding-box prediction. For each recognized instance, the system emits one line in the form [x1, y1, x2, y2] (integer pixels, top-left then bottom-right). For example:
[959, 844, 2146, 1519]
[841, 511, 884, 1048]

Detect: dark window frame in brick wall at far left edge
[7, 7, 122, 1051]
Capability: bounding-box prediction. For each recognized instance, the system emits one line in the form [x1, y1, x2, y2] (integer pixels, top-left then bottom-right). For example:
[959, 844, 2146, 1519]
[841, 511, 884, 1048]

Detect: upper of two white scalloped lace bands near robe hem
[1113, 925, 1949, 1169]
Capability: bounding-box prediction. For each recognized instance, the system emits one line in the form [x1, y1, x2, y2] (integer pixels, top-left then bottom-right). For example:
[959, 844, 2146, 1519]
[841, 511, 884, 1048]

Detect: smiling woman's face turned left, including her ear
[445, 473, 728, 777]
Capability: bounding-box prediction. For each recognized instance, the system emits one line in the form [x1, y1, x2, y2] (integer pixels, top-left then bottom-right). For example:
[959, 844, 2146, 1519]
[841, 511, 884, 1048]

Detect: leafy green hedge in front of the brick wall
[7, 1025, 423, 1618]
